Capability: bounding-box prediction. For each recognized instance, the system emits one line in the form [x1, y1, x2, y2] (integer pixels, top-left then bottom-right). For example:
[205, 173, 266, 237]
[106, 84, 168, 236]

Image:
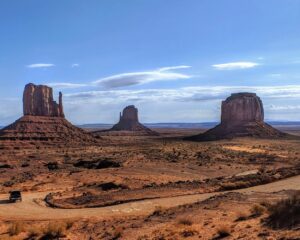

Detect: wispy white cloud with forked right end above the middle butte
[92, 65, 192, 88]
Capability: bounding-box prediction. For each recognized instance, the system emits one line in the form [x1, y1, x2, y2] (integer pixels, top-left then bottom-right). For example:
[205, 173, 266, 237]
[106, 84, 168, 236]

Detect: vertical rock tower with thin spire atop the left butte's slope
[23, 83, 65, 118]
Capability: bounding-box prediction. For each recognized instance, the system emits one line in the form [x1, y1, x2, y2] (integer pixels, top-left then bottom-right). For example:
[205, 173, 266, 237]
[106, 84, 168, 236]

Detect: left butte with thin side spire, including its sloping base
[0, 83, 95, 143]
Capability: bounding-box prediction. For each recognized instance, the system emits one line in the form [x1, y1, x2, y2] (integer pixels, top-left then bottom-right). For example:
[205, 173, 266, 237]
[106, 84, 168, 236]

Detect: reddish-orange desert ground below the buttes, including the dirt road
[0, 126, 300, 240]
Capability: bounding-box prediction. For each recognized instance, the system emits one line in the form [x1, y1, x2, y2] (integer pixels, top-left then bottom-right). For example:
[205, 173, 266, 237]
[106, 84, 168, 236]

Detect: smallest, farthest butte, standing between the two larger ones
[95, 105, 158, 135]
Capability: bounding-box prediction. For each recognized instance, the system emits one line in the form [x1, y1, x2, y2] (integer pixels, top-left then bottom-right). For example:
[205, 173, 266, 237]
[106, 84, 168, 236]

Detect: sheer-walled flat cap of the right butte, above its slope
[221, 93, 264, 125]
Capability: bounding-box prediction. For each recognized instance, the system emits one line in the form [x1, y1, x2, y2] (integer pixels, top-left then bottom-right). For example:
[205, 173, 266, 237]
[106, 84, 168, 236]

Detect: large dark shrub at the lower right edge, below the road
[266, 191, 300, 229]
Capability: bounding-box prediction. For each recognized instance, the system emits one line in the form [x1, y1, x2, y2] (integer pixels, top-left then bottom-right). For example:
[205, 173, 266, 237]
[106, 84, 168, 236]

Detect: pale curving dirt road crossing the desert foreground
[0, 175, 300, 220]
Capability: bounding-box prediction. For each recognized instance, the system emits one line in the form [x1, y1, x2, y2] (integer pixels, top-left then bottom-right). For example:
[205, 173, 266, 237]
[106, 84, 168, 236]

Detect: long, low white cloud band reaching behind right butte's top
[65, 85, 300, 103]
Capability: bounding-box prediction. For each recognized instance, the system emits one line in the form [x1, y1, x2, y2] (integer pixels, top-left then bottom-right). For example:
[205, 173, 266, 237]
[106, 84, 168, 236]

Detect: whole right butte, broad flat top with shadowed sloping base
[186, 93, 289, 141]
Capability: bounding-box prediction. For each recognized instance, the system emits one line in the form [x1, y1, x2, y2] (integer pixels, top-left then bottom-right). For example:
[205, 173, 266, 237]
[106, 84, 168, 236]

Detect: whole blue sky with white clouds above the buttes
[0, 0, 300, 125]
